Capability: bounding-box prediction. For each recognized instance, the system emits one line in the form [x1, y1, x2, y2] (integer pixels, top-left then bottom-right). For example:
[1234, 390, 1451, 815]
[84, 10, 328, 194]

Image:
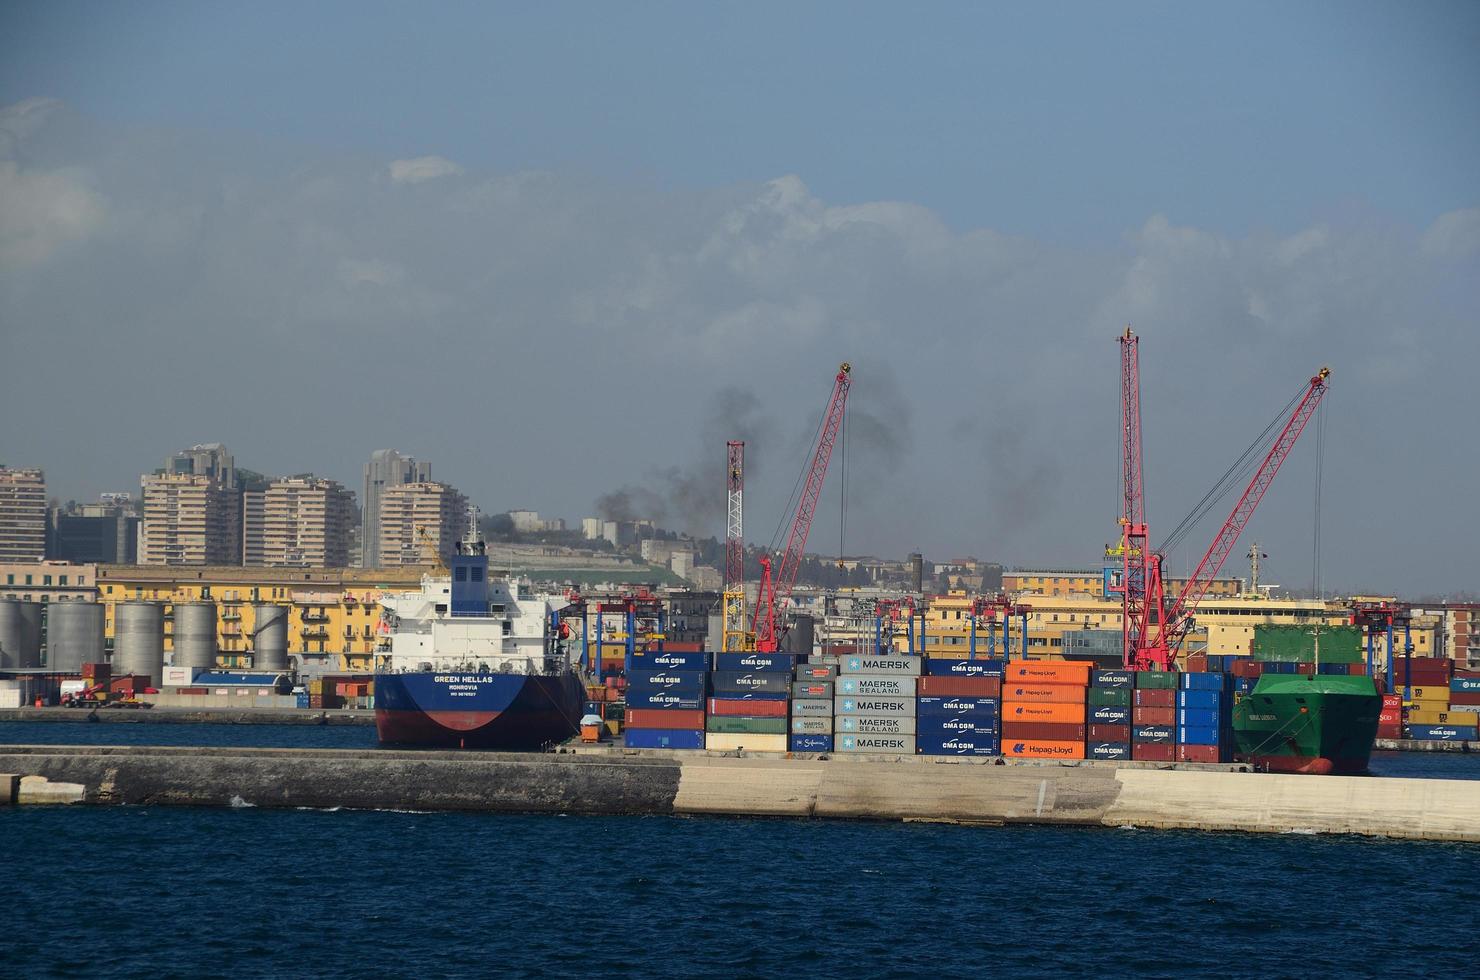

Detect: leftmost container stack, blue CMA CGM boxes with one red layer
[623, 650, 709, 749]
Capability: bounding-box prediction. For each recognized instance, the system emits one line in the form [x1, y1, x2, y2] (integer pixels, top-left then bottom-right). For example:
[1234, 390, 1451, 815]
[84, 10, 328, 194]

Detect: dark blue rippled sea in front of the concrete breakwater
[0, 807, 1480, 980]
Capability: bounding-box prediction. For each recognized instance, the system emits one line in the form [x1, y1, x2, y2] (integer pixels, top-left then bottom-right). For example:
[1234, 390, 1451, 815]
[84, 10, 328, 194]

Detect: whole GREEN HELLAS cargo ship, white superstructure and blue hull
[374, 542, 585, 751]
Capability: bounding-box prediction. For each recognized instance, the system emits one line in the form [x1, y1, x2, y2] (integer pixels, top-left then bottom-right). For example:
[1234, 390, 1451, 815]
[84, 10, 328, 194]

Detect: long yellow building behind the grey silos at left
[96, 565, 431, 671]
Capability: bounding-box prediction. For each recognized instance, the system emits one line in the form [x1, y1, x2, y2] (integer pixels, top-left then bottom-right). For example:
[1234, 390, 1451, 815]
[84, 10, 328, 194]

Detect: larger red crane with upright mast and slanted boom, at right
[1109, 327, 1331, 671]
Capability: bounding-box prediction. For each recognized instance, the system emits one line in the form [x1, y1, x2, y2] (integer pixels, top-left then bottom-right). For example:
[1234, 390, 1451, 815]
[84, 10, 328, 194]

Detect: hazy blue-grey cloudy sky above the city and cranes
[0, 0, 1480, 595]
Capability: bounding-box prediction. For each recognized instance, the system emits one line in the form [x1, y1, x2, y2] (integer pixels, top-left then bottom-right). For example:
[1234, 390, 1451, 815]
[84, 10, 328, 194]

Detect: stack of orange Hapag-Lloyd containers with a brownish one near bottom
[1002, 660, 1092, 759]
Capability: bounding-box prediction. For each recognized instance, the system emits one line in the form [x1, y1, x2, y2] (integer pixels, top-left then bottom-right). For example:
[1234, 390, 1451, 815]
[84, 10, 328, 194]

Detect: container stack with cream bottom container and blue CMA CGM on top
[704, 653, 796, 752]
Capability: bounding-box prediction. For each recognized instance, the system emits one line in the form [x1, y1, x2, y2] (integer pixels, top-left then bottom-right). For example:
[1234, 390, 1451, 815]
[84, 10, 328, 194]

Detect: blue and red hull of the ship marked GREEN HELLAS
[374, 671, 585, 752]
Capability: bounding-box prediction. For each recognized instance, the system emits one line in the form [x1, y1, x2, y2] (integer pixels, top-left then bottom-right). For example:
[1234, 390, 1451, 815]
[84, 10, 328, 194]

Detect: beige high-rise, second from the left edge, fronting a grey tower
[139, 472, 241, 565]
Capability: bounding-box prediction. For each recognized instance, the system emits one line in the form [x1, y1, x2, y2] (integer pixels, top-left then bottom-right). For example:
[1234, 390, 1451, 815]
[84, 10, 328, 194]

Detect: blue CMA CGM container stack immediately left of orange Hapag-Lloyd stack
[915, 659, 1006, 755]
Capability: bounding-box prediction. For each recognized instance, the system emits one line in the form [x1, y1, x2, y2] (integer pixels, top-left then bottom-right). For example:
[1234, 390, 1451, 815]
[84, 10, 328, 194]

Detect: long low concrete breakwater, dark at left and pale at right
[0, 746, 1480, 842]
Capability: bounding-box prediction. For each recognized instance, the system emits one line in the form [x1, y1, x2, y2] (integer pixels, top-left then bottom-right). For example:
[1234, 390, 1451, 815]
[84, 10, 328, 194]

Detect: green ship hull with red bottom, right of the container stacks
[1233, 674, 1382, 776]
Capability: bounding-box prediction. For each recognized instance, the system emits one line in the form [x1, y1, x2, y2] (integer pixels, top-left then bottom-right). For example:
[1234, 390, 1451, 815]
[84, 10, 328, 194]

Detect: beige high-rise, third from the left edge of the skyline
[243, 477, 354, 568]
